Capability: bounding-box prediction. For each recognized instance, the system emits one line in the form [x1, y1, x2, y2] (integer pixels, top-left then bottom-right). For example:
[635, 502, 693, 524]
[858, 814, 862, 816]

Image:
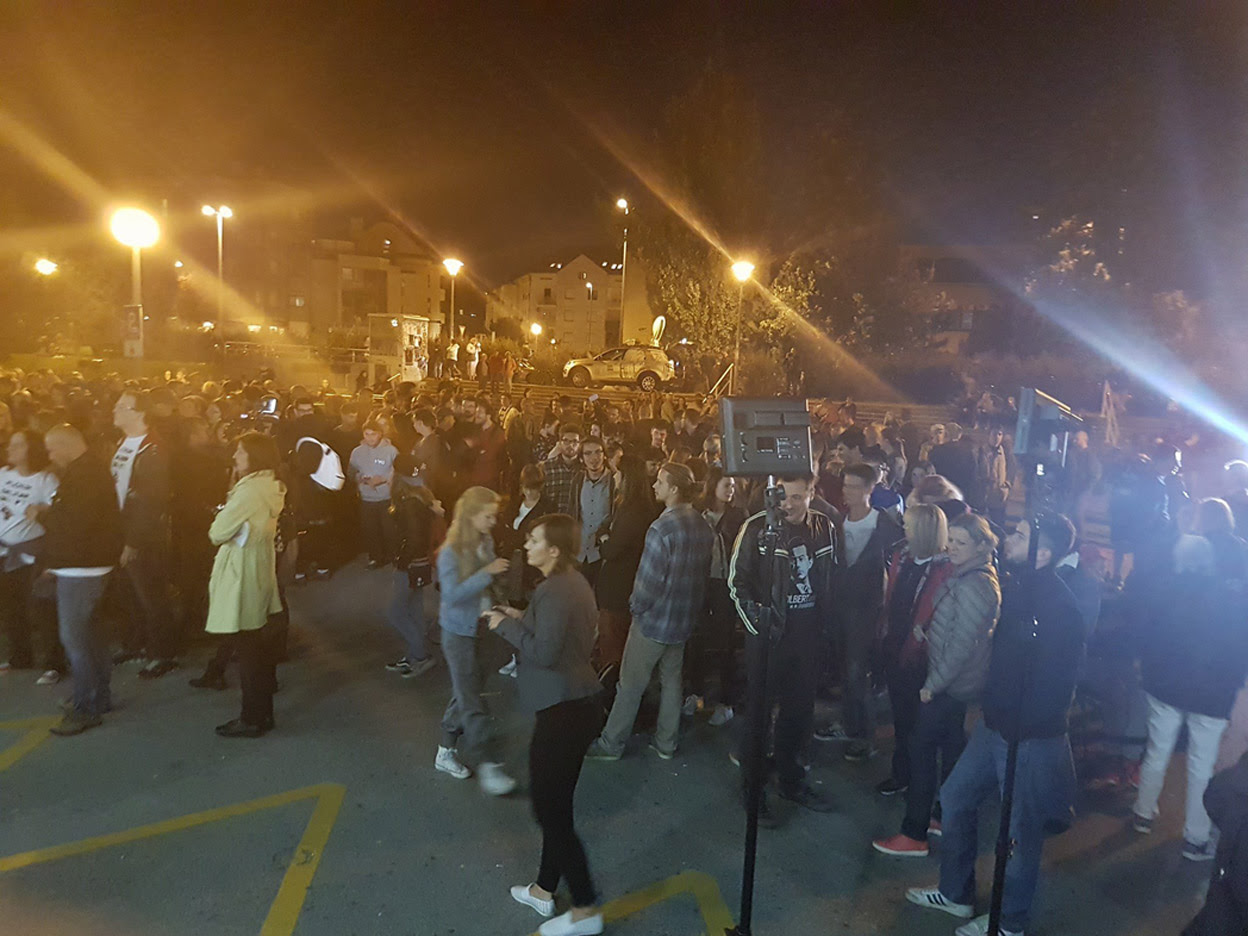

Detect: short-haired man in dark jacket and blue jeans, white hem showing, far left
[42, 426, 124, 735]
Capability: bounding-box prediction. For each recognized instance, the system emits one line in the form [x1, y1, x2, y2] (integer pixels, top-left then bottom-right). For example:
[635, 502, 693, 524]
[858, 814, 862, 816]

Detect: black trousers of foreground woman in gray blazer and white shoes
[529, 696, 603, 907]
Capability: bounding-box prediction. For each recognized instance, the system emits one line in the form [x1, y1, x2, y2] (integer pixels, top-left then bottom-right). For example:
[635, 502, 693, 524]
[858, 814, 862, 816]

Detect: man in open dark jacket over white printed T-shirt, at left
[111, 391, 177, 679]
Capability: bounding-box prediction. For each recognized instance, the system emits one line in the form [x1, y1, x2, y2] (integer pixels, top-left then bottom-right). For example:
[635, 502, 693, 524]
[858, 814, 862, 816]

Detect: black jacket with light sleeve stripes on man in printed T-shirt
[728, 509, 843, 635]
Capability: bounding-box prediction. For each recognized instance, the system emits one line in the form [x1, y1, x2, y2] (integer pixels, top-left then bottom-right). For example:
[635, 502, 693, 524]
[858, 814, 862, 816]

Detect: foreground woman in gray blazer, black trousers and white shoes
[487, 514, 603, 936]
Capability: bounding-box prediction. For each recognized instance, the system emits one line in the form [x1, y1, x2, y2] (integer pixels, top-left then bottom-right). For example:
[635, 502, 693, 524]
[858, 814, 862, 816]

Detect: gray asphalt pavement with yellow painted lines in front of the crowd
[0, 563, 1209, 936]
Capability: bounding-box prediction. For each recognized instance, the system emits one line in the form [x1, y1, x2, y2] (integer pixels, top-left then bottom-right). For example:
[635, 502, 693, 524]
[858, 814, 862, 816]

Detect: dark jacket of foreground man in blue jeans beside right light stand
[983, 568, 1085, 740]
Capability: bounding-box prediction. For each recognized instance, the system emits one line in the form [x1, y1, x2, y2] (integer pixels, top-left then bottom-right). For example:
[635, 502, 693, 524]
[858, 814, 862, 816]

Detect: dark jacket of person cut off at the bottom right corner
[1183, 754, 1248, 936]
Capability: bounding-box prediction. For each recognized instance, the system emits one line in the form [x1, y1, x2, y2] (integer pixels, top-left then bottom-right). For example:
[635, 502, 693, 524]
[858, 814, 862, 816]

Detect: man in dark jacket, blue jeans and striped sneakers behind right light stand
[906, 514, 1086, 936]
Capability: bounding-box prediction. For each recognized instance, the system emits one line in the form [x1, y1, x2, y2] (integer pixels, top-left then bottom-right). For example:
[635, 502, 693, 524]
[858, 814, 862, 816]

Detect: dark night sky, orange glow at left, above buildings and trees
[0, 1, 1248, 291]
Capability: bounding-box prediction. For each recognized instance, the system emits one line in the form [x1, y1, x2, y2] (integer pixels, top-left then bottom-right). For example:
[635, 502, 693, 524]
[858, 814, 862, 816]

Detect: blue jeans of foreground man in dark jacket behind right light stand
[940, 721, 1075, 930]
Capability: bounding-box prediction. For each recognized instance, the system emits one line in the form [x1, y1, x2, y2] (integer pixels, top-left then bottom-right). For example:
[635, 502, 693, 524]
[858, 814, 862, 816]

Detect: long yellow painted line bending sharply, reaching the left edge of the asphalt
[0, 778, 347, 936]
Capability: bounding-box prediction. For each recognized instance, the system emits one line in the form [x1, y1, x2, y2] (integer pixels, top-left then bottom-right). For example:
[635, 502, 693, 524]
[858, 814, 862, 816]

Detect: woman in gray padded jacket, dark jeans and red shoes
[872, 514, 1001, 857]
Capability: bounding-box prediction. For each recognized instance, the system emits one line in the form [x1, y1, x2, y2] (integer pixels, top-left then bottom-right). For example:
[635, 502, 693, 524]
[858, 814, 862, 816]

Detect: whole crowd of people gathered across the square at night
[0, 373, 1248, 936]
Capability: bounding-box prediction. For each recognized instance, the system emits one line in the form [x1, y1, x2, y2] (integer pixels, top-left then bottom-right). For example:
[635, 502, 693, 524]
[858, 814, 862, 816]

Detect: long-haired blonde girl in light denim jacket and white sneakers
[433, 488, 515, 796]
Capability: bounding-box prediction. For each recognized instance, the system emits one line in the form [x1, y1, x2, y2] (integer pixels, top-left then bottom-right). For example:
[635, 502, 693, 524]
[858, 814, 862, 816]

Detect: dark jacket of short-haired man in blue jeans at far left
[39, 454, 124, 569]
